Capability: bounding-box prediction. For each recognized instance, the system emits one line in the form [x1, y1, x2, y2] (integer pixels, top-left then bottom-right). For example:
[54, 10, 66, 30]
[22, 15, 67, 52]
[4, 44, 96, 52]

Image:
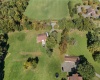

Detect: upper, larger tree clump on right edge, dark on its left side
[87, 28, 100, 53]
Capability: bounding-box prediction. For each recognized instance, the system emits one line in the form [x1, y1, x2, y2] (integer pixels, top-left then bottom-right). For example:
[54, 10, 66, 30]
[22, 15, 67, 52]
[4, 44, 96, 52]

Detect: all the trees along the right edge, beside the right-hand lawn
[87, 28, 100, 63]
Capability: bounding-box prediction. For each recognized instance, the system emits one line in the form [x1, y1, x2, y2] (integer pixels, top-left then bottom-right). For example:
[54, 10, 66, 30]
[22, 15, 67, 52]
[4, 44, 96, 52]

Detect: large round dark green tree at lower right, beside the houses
[78, 62, 95, 80]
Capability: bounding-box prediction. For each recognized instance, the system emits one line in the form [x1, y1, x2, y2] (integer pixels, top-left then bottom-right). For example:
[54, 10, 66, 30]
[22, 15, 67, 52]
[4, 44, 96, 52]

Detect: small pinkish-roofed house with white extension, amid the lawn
[37, 32, 48, 46]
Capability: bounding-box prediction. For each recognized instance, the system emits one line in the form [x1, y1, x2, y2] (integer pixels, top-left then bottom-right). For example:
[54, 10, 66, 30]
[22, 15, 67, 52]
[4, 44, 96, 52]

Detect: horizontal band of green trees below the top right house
[58, 17, 95, 31]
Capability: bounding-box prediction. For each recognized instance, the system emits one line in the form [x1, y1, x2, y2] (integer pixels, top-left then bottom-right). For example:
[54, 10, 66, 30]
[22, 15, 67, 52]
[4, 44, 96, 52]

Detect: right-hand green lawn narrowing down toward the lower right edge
[67, 31, 100, 74]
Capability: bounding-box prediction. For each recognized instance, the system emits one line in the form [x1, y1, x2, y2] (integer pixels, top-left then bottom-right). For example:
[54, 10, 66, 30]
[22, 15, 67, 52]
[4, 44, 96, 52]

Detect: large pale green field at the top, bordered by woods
[24, 0, 82, 20]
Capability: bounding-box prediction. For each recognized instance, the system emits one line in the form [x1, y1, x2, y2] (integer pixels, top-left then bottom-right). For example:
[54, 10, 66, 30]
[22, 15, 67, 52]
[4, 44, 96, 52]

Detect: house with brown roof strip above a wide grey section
[61, 56, 80, 72]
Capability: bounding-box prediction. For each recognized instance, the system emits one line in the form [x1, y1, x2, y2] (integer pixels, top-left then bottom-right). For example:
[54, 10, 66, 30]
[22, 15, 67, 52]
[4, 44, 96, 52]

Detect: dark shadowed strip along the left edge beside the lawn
[0, 34, 9, 80]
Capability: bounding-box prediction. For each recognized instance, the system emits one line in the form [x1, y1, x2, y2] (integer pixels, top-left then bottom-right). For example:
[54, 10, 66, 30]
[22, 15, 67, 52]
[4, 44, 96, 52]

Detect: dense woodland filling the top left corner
[0, 0, 32, 32]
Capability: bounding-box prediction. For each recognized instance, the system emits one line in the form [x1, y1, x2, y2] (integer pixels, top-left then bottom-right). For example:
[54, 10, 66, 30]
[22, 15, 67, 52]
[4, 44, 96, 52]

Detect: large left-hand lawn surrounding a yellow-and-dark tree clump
[4, 30, 67, 80]
